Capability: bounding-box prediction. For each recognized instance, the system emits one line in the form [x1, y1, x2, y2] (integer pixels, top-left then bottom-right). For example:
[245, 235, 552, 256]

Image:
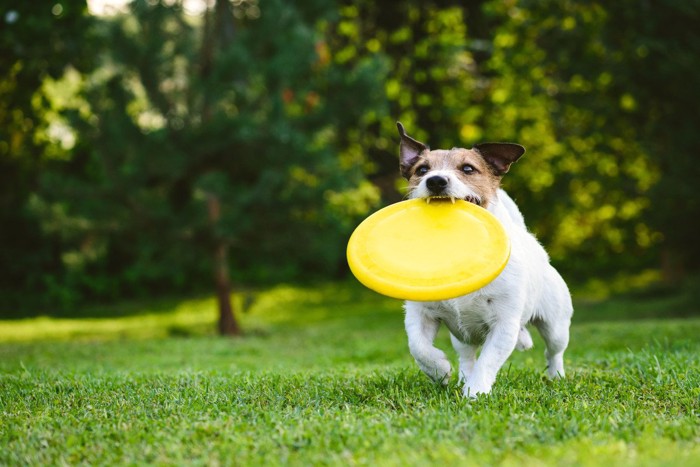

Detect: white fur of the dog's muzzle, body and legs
[400, 127, 573, 397]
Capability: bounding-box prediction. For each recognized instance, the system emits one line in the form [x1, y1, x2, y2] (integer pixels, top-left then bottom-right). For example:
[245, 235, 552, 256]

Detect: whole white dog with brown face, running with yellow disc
[397, 122, 573, 398]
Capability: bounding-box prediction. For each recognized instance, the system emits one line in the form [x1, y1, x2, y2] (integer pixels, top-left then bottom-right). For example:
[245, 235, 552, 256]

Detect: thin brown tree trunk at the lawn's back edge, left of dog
[207, 194, 241, 336]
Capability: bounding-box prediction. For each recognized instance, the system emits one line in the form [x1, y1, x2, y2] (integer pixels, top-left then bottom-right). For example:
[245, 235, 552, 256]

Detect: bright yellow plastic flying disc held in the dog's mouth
[347, 199, 510, 301]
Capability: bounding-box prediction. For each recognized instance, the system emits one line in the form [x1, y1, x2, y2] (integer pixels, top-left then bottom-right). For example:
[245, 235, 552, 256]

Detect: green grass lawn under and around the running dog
[0, 284, 700, 466]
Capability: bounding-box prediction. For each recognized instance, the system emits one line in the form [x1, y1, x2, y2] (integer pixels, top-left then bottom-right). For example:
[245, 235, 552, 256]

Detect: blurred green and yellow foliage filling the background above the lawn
[0, 0, 700, 309]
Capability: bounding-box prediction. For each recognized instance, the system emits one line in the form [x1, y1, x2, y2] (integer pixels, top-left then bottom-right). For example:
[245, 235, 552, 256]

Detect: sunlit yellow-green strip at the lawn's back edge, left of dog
[0, 284, 402, 342]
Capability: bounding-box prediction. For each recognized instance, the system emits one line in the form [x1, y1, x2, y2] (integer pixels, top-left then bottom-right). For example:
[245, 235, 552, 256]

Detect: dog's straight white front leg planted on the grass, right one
[463, 320, 520, 397]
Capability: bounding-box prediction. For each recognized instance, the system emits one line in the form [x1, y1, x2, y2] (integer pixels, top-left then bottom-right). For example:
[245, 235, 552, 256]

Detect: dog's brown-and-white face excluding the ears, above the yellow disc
[408, 148, 501, 207]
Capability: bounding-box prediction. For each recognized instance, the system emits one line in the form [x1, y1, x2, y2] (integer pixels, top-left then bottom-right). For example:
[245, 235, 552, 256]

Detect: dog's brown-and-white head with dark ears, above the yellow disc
[396, 122, 525, 208]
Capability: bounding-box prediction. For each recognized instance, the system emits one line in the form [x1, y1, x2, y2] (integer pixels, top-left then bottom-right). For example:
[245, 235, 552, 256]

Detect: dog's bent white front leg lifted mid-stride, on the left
[405, 302, 452, 384]
